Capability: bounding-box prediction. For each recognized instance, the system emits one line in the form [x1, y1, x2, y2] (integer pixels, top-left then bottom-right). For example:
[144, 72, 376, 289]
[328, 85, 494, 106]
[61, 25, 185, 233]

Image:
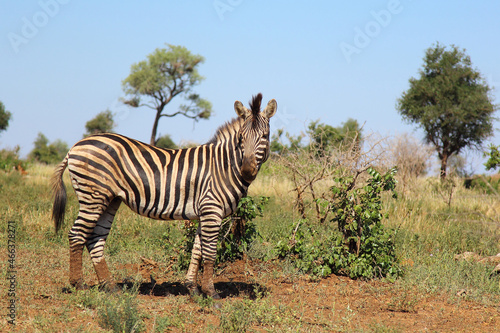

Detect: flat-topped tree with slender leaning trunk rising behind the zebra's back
[122, 44, 212, 145]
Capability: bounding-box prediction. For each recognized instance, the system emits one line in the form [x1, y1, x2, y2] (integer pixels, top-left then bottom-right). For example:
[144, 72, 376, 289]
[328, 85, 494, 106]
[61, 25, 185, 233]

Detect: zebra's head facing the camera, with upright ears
[234, 94, 278, 182]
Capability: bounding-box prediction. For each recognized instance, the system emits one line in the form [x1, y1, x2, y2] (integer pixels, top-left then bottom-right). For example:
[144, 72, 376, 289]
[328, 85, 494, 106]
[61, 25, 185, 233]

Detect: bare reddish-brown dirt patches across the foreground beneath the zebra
[2, 255, 500, 332]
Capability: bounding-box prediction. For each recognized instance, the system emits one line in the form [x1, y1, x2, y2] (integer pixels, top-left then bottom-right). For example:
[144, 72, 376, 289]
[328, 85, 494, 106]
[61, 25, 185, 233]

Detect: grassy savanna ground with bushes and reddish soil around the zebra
[0, 127, 500, 332]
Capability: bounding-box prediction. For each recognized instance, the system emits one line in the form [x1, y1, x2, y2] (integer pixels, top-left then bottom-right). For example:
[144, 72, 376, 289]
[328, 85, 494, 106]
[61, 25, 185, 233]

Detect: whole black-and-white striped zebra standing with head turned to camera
[52, 94, 277, 298]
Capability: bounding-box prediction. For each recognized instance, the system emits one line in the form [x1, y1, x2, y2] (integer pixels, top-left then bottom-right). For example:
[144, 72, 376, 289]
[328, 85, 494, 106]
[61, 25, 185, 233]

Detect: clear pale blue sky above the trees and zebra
[0, 0, 500, 172]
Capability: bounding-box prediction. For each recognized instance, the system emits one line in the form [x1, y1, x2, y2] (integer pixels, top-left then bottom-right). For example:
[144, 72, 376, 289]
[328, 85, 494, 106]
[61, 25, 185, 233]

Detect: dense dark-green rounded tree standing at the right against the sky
[397, 43, 497, 179]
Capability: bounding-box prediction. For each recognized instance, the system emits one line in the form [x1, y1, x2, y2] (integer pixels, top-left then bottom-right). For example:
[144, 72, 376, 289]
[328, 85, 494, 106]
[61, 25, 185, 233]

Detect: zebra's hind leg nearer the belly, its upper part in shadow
[86, 198, 121, 289]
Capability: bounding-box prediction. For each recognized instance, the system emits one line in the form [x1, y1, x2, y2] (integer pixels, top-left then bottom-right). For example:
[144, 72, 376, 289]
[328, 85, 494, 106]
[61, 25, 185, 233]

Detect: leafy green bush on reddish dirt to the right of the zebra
[276, 169, 402, 279]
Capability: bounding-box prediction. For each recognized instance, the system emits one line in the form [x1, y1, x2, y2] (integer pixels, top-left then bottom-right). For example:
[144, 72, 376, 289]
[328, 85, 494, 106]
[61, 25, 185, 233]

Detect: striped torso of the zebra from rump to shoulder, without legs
[68, 134, 213, 220]
